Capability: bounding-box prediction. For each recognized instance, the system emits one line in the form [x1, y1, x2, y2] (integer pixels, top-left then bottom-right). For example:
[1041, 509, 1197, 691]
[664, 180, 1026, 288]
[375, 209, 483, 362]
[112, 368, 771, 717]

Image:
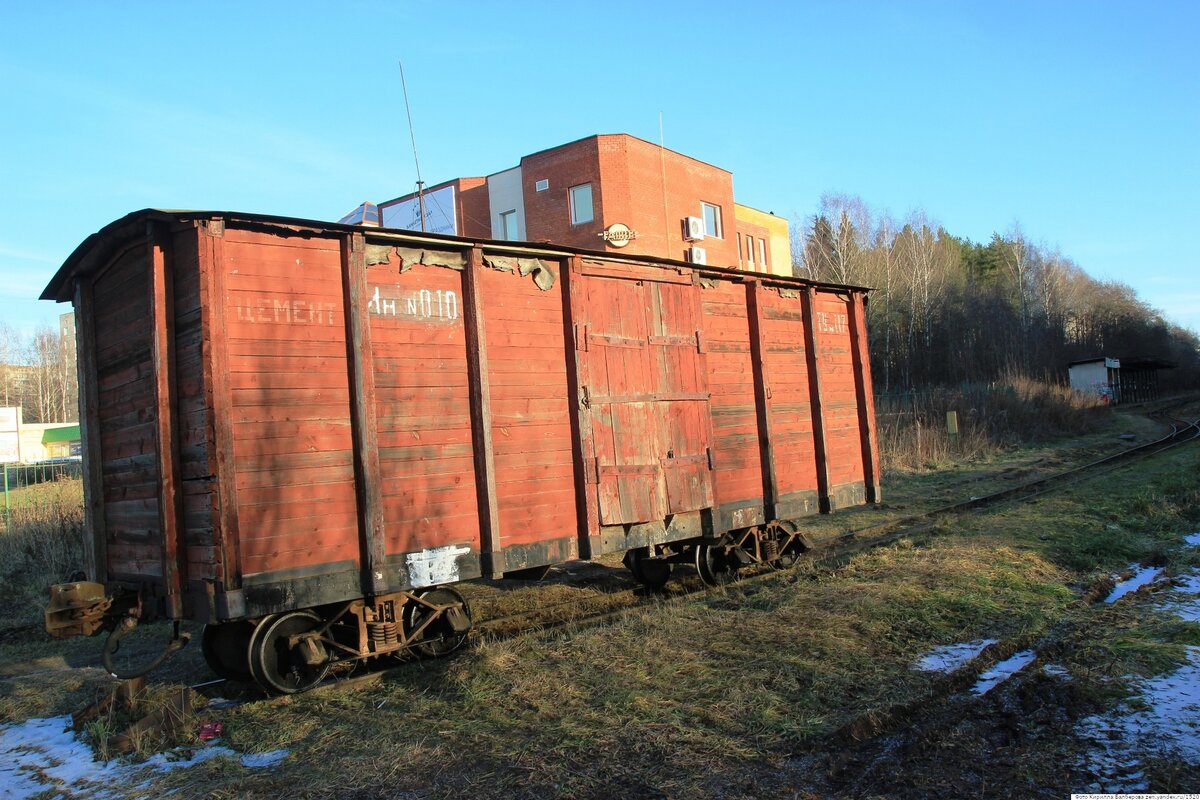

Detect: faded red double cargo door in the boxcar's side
[577, 272, 713, 525]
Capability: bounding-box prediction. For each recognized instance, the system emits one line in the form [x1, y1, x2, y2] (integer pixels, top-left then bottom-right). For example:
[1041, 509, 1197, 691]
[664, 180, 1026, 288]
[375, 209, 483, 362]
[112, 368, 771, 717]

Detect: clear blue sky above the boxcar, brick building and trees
[0, 0, 1200, 331]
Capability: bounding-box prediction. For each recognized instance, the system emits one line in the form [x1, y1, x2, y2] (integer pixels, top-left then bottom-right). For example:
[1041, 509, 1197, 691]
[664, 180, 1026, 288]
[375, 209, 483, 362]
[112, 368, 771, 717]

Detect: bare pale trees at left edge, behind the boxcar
[0, 321, 79, 423]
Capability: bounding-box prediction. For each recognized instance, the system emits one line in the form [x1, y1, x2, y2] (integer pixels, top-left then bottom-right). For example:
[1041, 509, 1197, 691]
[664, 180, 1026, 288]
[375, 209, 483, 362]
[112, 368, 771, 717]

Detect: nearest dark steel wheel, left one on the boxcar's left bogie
[250, 610, 330, 694]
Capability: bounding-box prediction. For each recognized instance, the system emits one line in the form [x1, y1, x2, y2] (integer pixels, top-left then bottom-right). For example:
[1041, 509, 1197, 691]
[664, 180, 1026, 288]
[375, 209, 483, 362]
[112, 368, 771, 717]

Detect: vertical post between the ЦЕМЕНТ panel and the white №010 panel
[340, 231, 388, 595]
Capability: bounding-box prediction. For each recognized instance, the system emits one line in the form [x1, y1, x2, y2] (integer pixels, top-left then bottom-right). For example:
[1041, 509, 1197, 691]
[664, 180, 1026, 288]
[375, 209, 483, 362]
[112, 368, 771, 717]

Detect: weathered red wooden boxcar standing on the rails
[43, 210, 880, 691]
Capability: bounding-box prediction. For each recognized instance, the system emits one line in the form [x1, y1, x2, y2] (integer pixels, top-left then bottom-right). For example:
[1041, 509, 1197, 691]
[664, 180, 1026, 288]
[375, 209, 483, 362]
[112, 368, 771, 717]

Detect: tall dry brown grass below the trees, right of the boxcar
[876, 375, 1112, 470]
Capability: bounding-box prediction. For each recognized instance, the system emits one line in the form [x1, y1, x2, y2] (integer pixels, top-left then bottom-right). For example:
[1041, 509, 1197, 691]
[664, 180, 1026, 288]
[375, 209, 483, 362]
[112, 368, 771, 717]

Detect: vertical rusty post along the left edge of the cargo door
[559, 255, 600, 559]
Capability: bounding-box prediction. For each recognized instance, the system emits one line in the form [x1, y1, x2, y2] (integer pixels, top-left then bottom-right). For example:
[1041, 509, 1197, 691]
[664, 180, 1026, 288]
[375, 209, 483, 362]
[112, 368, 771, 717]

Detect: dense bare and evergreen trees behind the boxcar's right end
[792, 194, 1200, 393]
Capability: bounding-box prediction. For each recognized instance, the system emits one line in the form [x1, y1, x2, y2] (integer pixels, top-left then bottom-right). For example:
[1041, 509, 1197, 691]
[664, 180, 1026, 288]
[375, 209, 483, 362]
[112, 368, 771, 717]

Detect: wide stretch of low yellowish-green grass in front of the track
[131, 443, 1200, 798]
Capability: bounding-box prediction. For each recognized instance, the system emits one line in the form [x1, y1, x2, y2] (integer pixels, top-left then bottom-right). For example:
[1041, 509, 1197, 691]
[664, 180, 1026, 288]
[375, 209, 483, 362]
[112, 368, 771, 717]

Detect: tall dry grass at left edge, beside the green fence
[0, 479, 85, 627]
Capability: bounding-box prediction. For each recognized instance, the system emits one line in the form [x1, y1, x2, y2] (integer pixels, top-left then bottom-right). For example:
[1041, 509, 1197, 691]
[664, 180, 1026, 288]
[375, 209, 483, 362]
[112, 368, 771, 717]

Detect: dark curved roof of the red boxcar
[41, 209, 870, 302]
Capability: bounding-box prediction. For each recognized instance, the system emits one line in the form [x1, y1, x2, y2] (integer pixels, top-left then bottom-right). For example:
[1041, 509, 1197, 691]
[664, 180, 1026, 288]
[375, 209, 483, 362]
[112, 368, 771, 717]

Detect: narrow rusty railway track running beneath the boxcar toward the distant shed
[193, 401, 1200, 700]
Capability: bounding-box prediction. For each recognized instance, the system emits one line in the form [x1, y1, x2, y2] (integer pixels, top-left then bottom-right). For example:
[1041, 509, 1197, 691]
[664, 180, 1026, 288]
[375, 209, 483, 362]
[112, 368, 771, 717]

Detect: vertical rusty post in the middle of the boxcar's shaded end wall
[146, 222, 187, 619]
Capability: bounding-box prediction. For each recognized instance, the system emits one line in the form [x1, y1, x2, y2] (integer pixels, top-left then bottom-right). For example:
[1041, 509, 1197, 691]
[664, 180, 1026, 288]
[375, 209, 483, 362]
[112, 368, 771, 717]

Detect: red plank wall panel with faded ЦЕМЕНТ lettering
[220, 228, 359, 575]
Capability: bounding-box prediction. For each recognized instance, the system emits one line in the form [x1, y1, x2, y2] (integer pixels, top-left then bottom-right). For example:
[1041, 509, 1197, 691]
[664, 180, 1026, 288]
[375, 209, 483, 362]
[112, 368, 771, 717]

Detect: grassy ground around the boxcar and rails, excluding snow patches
[0, 417, 1200, 798]
